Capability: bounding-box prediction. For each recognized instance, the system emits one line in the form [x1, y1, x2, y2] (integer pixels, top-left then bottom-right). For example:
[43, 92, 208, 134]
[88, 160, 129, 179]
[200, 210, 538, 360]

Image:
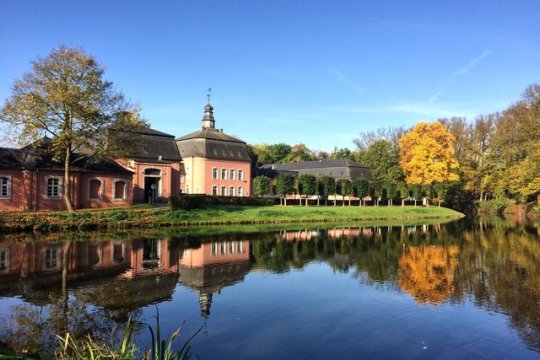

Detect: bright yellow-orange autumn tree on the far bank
[399, 121, 459, 185]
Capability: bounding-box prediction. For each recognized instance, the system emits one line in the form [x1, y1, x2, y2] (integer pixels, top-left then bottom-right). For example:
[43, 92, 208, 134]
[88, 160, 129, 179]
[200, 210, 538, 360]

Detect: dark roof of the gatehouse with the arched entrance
[132, 128, 182, 161]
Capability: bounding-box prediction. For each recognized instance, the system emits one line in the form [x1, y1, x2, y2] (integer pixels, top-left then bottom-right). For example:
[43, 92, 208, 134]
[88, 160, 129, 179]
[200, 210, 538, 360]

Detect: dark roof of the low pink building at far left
[0, 147, 132, 174]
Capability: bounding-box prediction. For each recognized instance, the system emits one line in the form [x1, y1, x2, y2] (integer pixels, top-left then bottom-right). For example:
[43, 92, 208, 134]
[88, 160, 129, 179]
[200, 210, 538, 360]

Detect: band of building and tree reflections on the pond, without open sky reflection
[0, 221, 540, 356]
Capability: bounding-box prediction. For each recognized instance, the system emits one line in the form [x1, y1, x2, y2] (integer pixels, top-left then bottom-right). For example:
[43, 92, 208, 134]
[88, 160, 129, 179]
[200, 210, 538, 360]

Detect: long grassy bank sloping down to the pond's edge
[0, 205, 463, 232]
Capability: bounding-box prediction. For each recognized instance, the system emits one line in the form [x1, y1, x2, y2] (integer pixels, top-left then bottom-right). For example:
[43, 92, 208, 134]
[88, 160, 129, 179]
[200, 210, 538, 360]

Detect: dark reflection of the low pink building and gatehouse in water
[0, 239, 178, 307]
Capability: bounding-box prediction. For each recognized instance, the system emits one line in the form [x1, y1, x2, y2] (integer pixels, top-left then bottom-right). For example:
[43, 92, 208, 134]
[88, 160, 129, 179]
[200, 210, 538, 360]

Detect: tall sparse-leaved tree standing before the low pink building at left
[0, 47, 145, 211]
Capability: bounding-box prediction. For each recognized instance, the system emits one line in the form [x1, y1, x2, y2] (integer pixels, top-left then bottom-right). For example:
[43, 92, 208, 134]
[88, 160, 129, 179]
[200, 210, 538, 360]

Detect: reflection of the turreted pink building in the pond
[178, 240, 250, 317]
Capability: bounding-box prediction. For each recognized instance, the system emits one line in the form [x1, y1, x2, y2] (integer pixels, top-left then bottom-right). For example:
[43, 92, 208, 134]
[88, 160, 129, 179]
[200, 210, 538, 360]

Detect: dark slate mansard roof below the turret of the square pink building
[176, 129, 251, 162]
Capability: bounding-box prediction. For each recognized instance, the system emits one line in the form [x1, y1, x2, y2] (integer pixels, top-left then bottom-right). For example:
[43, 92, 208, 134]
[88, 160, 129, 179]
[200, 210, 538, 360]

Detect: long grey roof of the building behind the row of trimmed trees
[261, 159, 371, 180]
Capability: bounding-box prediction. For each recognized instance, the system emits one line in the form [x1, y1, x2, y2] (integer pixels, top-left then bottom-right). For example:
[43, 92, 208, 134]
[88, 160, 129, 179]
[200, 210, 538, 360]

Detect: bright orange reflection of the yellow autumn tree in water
[398, 246, 459, 304]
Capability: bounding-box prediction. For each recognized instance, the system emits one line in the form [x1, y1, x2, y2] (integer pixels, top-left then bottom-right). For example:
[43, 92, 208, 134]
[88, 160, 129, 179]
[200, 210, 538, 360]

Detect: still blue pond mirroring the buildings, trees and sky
[0, 221, 540, 359]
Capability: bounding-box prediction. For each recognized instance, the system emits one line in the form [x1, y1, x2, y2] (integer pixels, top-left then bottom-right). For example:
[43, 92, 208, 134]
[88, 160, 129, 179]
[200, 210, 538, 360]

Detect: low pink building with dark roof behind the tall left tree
[0, 147, 133, 211]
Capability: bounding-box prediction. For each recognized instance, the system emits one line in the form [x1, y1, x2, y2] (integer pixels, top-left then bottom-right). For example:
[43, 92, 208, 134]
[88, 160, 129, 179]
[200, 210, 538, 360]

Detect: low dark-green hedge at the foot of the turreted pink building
[169, 194, 279, 210]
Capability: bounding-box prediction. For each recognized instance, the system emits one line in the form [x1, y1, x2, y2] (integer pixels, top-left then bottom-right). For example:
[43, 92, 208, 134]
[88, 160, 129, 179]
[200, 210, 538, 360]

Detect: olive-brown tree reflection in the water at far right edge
[456, 219, 540, 350]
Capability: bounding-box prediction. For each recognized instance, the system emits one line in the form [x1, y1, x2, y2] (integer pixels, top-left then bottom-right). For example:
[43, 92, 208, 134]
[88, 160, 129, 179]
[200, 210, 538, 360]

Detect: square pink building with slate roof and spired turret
[176, 103, 251, 197]
